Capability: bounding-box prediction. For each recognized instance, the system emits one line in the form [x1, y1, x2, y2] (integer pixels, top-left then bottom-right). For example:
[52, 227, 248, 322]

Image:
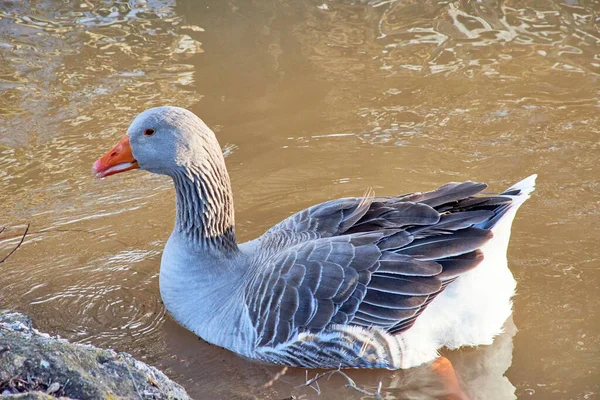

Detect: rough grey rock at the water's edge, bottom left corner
[0, 311, 190, 400]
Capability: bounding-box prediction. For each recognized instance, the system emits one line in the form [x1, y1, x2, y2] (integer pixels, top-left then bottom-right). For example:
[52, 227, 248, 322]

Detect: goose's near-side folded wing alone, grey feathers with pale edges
[247, 227, 492, 346]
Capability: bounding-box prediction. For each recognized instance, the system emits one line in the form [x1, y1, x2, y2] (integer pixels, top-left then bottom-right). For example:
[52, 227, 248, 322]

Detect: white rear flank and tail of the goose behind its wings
[398, 175, 537, 368]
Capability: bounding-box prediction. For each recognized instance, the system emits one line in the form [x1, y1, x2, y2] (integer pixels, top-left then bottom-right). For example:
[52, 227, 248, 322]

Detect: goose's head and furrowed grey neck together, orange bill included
[92, 107, 237, 252]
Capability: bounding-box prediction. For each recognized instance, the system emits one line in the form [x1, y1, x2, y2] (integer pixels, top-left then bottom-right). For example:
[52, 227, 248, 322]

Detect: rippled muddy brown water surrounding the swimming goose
[0, 0, 600, 399]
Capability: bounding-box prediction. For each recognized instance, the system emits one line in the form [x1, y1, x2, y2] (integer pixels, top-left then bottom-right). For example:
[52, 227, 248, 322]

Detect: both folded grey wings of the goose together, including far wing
[247, 182, 524, 346]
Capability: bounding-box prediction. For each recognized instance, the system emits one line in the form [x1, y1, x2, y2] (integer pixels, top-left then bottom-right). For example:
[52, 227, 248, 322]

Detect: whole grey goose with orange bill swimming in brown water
[93, 107, 536, 369]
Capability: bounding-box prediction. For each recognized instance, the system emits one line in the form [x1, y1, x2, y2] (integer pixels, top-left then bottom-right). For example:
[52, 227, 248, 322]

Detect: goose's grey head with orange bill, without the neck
[92, 106, 222, 178]
